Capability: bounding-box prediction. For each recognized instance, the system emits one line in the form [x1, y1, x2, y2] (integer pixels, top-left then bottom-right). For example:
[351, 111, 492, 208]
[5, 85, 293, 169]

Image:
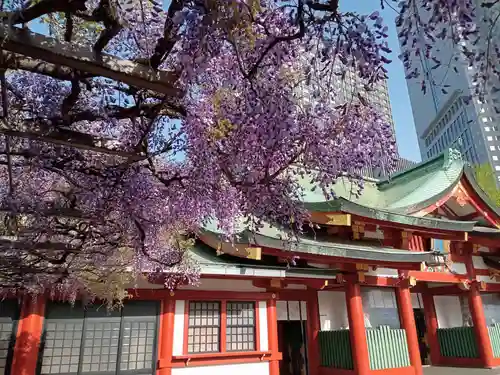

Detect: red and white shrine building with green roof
[5, 151, 500, 375]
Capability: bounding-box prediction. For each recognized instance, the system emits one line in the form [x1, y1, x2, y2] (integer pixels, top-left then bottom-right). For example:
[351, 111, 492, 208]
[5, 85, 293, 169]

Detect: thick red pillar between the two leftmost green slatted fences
[346, 283, 370, 375]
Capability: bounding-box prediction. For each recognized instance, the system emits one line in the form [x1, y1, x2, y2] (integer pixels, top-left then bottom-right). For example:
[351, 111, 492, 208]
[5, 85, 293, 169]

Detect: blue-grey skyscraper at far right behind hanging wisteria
[398, 0, 500, 186]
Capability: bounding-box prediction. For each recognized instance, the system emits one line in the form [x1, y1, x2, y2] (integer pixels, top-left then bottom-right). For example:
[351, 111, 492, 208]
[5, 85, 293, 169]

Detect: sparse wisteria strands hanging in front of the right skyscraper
[396, 0, 500, 102]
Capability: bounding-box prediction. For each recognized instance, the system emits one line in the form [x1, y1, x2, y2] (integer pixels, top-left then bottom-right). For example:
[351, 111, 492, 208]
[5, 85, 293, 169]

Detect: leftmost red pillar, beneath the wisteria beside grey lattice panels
[11, 296, 45, 375]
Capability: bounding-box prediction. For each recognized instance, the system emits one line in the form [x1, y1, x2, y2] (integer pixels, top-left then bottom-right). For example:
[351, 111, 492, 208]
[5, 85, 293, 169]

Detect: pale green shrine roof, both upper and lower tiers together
[197, 150, 500, 263]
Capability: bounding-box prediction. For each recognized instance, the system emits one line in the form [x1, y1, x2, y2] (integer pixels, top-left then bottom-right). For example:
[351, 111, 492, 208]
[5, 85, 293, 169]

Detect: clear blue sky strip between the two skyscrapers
[340, 0, 421, 161]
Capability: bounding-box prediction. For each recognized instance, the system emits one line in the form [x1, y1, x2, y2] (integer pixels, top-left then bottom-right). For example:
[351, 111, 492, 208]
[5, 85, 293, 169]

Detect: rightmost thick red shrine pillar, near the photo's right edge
[469, 283, 493, 368]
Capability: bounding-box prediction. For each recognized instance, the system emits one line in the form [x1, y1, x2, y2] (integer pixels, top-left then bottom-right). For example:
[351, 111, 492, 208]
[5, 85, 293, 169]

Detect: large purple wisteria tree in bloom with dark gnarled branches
[0, 0, 500, 301]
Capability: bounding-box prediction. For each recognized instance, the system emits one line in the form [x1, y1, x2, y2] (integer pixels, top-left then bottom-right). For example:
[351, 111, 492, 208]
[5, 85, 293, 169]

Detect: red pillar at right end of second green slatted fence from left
[397, 286, 423, 375]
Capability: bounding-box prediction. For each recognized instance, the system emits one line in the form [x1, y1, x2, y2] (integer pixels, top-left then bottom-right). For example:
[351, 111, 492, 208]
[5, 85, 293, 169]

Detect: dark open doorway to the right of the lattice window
[278, 320, 307, 375]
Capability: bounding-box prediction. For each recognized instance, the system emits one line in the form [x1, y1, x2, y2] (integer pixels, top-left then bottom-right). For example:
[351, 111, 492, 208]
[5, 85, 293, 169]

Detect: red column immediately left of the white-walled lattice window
[158, 298, 175, 375]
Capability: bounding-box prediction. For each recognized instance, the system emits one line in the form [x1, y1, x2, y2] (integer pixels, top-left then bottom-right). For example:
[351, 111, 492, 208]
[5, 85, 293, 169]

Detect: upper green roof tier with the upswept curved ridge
[294, 150, 500, 231]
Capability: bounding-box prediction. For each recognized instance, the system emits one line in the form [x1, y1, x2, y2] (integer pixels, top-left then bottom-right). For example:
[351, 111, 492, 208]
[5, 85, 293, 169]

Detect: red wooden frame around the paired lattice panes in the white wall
[182, 298, 261, 358]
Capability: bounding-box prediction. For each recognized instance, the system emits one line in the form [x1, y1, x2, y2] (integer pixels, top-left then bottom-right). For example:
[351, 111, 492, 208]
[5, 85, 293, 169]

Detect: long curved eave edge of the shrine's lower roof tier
[199, 231, 435, 263]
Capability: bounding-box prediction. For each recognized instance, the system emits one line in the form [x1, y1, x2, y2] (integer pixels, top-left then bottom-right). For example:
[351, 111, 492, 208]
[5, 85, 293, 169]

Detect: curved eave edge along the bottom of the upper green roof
[305, 198, 476, 232]
